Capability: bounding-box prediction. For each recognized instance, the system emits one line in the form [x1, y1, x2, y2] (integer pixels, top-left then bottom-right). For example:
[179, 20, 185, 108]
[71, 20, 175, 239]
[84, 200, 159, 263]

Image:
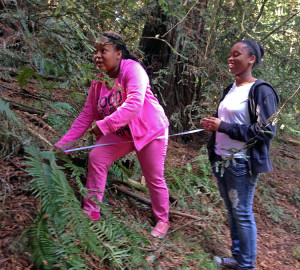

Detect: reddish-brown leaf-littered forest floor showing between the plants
[0, 77, 300, 270]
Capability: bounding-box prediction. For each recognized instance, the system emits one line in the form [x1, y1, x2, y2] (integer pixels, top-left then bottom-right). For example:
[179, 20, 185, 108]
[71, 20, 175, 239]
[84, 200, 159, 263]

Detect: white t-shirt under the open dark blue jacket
[215, 82, 254, 158]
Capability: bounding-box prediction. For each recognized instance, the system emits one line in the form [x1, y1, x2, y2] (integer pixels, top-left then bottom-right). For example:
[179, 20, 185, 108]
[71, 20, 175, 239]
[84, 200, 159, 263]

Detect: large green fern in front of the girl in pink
[26, 148, 145, 269]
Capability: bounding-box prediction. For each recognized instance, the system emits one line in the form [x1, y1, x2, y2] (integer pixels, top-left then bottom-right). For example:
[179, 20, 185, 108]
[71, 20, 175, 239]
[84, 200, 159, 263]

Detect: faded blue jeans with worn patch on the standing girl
[212, 156, 258, 269]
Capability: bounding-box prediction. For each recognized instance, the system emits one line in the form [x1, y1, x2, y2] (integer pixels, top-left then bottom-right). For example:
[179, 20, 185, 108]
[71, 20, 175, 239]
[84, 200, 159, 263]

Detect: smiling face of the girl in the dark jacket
[228, 42, 255, 76]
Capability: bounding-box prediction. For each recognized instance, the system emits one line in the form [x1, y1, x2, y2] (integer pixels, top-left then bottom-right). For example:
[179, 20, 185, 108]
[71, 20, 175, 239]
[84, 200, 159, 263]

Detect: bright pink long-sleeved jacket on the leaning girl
[55, 59, 169, 151]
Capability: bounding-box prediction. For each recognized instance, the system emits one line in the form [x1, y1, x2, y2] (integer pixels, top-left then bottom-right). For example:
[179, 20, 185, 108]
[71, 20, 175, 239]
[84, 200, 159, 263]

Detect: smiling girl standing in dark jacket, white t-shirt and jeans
[202, 39, 279, 269]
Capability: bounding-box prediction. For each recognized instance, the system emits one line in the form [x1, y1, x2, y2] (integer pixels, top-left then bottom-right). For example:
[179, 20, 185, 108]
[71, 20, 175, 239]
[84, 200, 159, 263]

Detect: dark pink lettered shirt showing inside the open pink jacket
[97, 83, 132, 138]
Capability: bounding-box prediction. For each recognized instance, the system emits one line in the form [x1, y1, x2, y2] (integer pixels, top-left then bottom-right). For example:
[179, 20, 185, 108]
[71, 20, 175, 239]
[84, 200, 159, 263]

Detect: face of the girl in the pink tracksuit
[94, 37, 122, 77]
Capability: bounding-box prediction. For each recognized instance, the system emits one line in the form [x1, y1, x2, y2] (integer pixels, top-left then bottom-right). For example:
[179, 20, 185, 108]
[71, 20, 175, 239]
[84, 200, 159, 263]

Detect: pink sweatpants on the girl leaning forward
[83, 130, 169, 222]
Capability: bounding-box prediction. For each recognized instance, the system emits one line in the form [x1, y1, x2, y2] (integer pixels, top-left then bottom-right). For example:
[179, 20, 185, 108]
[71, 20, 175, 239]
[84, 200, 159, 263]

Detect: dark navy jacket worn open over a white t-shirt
[207, 79, 279, 173]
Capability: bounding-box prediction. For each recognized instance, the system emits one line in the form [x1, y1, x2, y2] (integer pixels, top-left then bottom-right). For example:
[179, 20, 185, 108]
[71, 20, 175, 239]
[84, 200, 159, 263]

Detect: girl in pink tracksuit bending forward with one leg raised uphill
[56, 32, 169, 238]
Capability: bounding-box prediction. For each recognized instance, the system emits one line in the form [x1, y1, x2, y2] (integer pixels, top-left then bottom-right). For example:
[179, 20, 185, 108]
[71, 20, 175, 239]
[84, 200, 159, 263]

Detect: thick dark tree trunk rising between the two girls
[140, 0, 207, 137]
